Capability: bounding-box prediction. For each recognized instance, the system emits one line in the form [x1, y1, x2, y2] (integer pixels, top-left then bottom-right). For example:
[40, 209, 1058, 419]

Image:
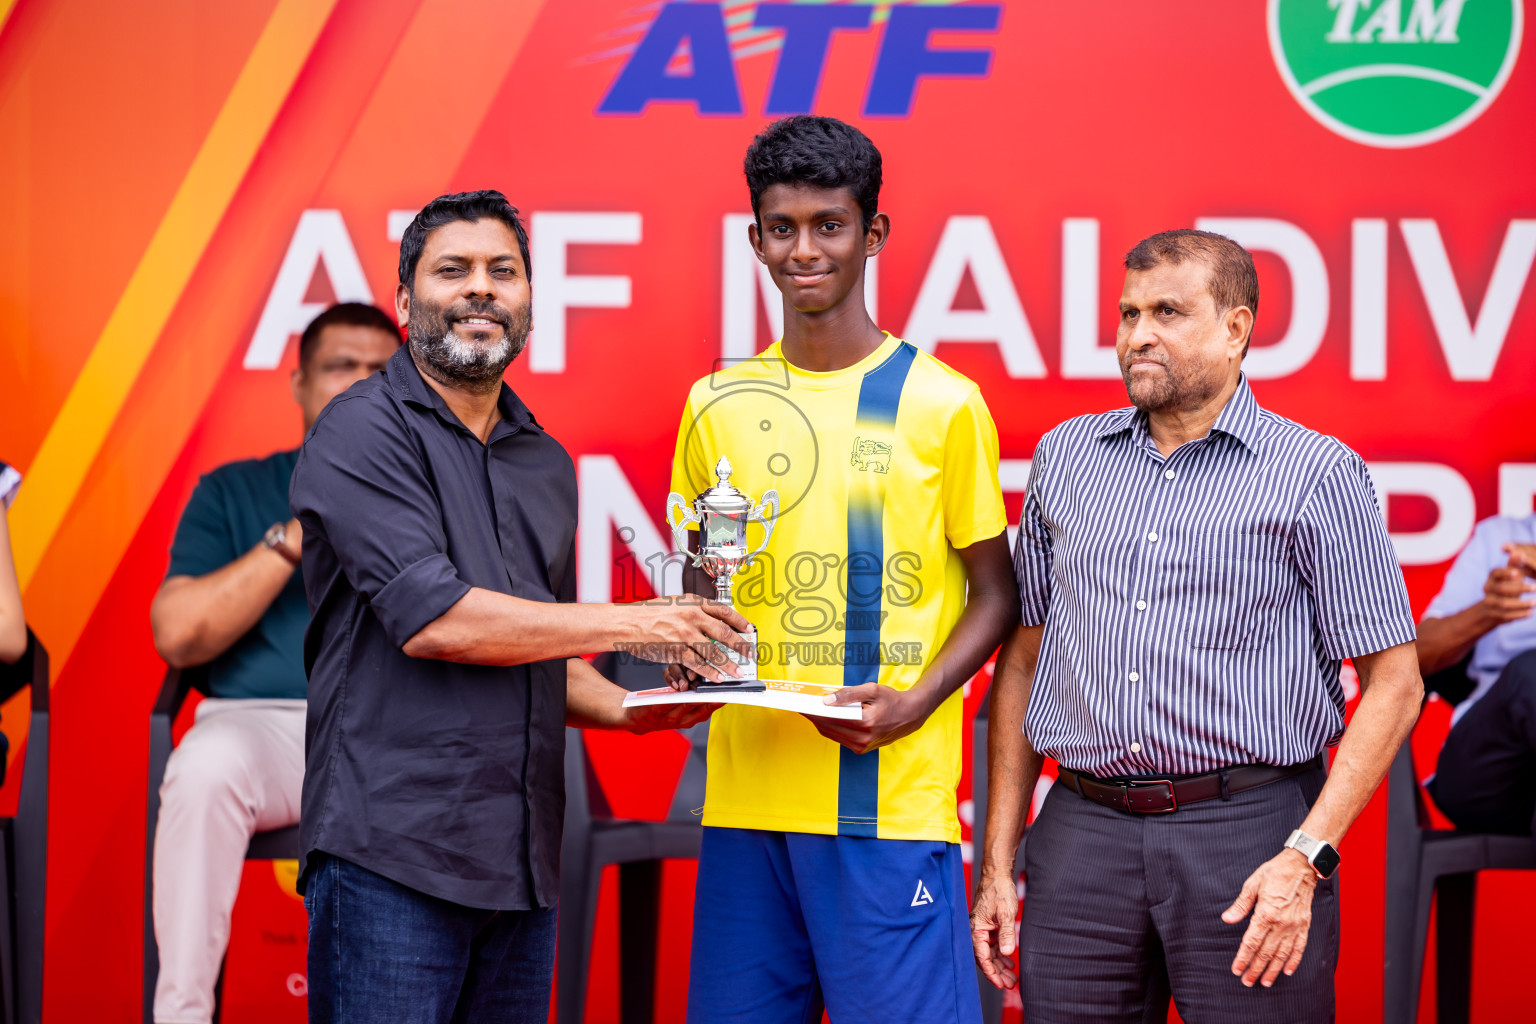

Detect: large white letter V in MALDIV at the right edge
[1401, 220, 1536, 381]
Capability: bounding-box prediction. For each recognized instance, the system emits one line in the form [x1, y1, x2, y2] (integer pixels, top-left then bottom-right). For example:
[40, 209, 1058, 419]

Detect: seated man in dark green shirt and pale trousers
[148, 302, 401, 1024]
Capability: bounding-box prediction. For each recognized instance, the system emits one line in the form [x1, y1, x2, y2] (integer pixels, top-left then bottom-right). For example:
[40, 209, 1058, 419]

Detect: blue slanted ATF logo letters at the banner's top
[598, 3, 1003, 117]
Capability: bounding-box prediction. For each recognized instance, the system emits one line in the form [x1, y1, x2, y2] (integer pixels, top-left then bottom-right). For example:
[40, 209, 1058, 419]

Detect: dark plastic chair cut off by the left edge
[0, 629, 48, 1024]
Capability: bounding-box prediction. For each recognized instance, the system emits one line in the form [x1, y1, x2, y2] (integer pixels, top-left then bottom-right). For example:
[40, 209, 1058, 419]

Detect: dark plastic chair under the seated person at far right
[1382, 666, 1536, 1024]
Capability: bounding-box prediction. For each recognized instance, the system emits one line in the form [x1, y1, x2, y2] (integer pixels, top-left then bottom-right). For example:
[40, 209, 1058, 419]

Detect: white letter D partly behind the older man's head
[1195, 216, 1329, 381]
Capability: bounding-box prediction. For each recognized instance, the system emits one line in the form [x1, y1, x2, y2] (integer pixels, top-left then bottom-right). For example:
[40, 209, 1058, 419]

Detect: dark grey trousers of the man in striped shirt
[1020, 769, 1339, 1024]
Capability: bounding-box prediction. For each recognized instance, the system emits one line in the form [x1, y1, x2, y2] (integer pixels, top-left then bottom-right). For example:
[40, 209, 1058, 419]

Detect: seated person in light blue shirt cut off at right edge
[1419, 514, 1536, 835]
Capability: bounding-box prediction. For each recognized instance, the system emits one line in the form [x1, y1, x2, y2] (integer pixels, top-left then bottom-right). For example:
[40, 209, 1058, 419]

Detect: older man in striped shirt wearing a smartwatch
[972, 230, 1422, 1024]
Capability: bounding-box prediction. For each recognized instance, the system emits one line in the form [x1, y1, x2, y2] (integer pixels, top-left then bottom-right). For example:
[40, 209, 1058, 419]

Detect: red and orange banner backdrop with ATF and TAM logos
[0, 0, 1536, 1022]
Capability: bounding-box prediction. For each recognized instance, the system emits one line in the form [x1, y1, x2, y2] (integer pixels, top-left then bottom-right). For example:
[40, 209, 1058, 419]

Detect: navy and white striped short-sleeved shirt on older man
[1014, 378, 1415, 775]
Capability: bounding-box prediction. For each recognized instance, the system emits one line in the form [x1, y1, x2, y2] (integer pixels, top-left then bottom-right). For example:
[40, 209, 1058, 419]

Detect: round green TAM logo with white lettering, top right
[1269, 0, 1524, 147]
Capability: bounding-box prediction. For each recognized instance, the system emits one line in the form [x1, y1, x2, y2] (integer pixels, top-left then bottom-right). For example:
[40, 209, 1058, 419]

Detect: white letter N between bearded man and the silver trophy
[576, 454, 682, 603]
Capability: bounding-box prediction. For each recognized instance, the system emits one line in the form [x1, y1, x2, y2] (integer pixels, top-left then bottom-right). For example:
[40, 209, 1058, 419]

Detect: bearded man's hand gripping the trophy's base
[622, 594, 756, 689]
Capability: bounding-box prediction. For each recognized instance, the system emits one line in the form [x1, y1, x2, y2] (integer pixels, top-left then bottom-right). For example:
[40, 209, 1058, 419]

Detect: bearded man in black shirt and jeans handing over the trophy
[290, 192, 748, 1024]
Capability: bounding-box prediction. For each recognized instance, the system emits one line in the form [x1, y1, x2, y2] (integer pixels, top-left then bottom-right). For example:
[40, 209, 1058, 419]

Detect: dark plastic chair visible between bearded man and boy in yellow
[556, 656, 710, 1024]
